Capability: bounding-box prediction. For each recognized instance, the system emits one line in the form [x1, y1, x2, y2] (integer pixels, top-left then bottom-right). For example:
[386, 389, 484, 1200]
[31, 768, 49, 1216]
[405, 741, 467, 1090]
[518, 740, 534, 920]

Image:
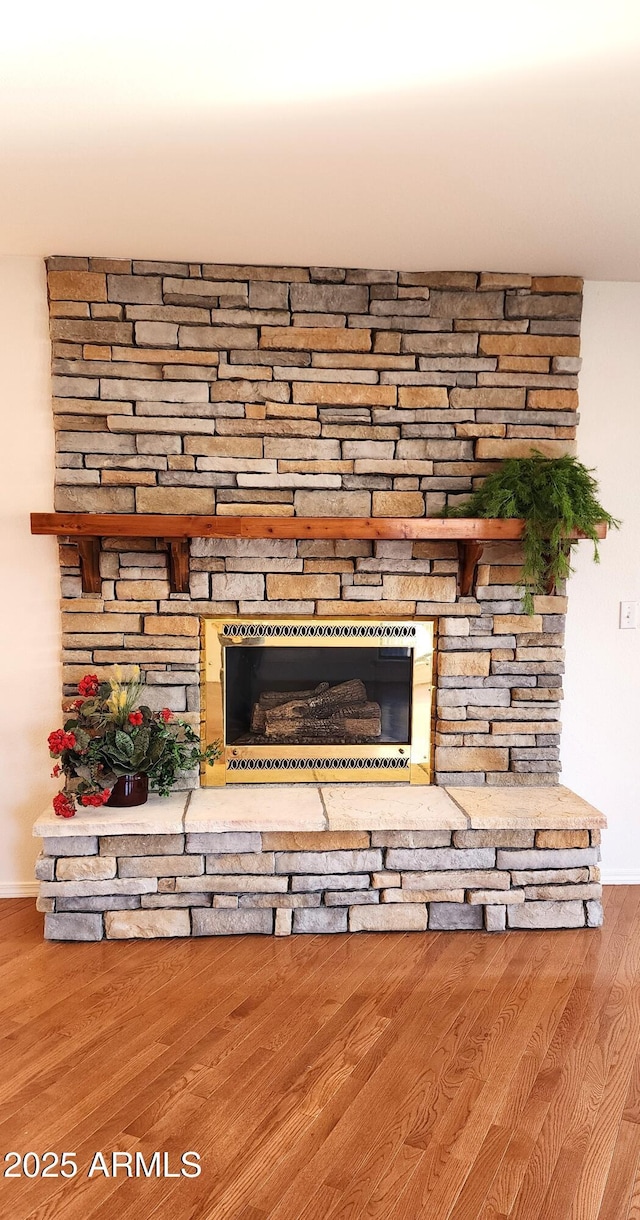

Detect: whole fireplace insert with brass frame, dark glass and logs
[202, 616, 435, 786]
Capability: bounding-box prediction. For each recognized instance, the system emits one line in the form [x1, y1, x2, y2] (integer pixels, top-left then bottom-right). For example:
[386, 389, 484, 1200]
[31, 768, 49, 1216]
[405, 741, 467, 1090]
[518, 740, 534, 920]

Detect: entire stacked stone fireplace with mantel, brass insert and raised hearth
[28, 257, 605, 939]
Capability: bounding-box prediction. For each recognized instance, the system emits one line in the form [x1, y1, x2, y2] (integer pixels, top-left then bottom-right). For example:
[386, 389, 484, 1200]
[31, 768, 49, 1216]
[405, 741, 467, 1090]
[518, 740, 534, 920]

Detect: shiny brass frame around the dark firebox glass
[201, 615, 436, 787]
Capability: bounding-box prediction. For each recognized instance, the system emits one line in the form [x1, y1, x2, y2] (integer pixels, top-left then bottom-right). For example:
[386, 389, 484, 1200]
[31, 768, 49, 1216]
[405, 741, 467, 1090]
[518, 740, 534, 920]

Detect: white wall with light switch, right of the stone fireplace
[562, 282, 640, 882]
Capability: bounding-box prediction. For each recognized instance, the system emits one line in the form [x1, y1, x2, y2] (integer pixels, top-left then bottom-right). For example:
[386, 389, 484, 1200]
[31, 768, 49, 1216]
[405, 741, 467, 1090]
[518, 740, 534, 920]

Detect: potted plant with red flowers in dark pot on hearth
[49, 666, 219, 817]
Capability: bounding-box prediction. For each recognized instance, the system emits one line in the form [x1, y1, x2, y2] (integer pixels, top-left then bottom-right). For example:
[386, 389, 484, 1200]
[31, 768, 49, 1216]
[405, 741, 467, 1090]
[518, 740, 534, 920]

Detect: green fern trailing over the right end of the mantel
[446, 449, 619, 614]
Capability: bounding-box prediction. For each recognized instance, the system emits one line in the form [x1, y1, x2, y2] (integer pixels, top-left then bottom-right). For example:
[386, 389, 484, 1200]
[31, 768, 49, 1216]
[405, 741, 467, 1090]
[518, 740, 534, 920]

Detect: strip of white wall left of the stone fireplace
[0, 257, 60, 897]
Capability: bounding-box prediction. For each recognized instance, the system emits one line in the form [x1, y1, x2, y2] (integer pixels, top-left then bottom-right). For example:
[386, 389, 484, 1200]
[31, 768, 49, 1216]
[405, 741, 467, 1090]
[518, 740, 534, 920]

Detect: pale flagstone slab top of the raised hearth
[33, 783, 606, 838]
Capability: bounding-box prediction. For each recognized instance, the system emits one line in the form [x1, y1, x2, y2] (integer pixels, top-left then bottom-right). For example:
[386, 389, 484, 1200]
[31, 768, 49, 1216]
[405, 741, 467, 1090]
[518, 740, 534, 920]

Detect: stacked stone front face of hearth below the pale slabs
[37, 830, 602, 941]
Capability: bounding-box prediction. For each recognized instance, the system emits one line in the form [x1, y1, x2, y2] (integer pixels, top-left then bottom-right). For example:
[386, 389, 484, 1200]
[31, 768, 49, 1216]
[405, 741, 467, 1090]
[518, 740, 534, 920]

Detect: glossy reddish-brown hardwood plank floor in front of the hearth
[0, 886, 640, 1220]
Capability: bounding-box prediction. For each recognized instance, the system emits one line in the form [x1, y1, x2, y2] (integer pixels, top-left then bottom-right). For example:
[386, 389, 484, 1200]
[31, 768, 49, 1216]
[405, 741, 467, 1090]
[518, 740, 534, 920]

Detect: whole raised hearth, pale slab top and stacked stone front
[34, 784, 606, 941]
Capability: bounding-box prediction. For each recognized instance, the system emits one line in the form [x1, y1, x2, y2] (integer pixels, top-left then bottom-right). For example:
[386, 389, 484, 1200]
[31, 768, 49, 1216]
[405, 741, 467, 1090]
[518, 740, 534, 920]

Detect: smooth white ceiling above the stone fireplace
[0, 0, 640, 281]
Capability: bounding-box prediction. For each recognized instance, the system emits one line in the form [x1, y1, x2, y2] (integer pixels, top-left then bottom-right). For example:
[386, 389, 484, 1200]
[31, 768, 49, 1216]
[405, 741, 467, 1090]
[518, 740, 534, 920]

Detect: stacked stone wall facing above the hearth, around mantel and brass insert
[48, 257, 581, 786]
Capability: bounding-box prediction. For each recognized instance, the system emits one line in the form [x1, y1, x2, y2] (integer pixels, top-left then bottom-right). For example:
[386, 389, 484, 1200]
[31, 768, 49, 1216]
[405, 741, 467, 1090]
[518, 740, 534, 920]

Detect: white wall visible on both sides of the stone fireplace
[0, 257, 640, 895]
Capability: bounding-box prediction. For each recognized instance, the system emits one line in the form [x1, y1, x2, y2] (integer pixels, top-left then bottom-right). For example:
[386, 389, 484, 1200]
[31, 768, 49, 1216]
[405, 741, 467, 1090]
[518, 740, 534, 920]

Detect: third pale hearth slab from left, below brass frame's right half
[322, 783, 468, 831]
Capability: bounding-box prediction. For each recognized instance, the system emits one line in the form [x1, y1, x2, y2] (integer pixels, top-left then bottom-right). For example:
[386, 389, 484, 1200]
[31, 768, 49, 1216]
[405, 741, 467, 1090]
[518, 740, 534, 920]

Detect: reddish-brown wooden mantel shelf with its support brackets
[30, 512, 607, 597]
